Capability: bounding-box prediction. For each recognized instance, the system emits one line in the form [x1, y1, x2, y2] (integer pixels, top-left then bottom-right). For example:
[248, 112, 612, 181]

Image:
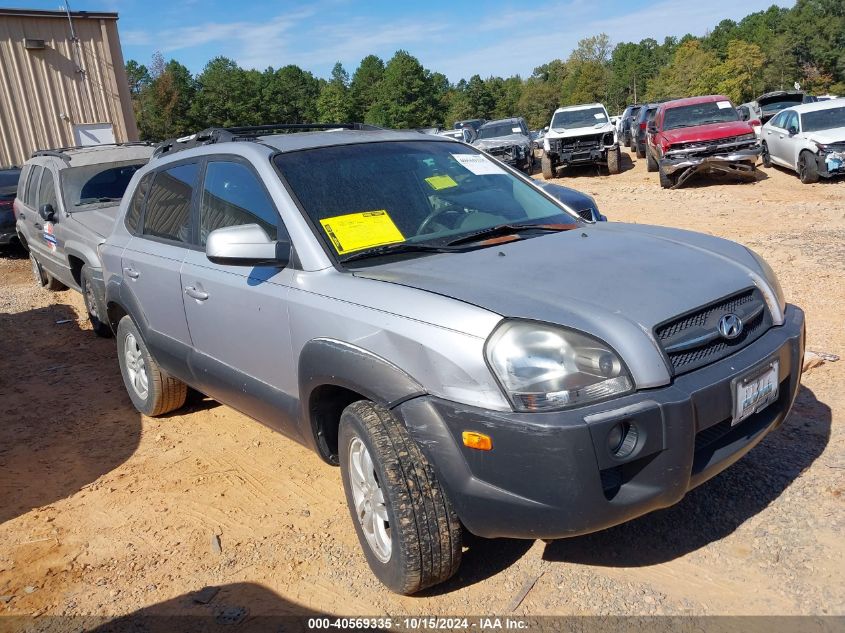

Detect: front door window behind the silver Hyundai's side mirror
[200, 161, 279, 246]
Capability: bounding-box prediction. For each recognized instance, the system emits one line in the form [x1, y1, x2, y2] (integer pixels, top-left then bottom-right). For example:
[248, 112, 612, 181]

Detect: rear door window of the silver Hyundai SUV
[144, 163, 199, 244]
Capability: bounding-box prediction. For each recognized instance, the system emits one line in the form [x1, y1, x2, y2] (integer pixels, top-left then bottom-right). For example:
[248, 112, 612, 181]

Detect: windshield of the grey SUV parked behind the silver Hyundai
[61, 160, 146, 212]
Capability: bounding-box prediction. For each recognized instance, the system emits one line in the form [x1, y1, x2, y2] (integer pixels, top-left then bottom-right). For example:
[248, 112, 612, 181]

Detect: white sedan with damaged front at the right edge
[762, 99, 845, 184]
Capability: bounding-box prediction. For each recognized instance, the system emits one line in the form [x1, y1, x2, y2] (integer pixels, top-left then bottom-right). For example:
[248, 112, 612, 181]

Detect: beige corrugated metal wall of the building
[0, 10, 138, 167]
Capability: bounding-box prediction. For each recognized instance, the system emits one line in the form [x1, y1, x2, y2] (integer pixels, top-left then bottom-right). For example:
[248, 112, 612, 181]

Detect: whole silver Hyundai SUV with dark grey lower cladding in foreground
[102, 126, 804, 593]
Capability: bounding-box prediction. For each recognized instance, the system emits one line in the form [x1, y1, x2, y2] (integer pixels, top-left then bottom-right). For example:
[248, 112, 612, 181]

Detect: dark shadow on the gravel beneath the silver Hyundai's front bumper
[543, 387, 831, 567]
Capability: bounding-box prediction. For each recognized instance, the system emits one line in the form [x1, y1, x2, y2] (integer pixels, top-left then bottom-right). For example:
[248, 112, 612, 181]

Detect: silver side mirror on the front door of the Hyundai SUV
[205, 224, 291, 268]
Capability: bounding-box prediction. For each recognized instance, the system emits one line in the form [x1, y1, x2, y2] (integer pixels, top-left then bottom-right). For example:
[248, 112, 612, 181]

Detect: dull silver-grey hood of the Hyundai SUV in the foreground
[354, 223, 760, 372]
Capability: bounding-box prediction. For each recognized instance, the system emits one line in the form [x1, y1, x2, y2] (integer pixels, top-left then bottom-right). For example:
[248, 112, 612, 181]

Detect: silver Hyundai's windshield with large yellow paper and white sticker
[274, 141, 579, 261]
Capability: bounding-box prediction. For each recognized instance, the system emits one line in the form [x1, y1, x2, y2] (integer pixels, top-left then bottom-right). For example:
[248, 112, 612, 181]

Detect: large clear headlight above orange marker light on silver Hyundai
[486, 321, 634, 411]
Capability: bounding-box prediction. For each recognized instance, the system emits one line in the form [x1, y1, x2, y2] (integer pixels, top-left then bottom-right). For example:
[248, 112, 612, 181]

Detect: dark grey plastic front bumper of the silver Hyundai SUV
[396, 306, 804, 539]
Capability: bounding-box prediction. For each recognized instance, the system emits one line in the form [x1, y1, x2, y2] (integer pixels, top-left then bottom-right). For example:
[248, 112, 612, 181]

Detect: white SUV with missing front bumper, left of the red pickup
[540, 103, 622, 179]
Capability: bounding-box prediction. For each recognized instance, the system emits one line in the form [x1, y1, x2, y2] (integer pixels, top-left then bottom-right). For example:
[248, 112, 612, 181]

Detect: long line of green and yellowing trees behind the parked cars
[126, 0, 845, 140]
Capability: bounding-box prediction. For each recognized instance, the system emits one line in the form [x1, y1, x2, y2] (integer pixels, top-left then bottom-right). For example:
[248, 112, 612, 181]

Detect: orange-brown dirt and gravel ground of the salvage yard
[0, 151, 845, 628]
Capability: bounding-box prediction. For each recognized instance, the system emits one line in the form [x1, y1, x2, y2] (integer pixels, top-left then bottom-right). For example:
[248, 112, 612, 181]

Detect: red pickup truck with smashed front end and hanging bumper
[646, 95, 760, 189]
